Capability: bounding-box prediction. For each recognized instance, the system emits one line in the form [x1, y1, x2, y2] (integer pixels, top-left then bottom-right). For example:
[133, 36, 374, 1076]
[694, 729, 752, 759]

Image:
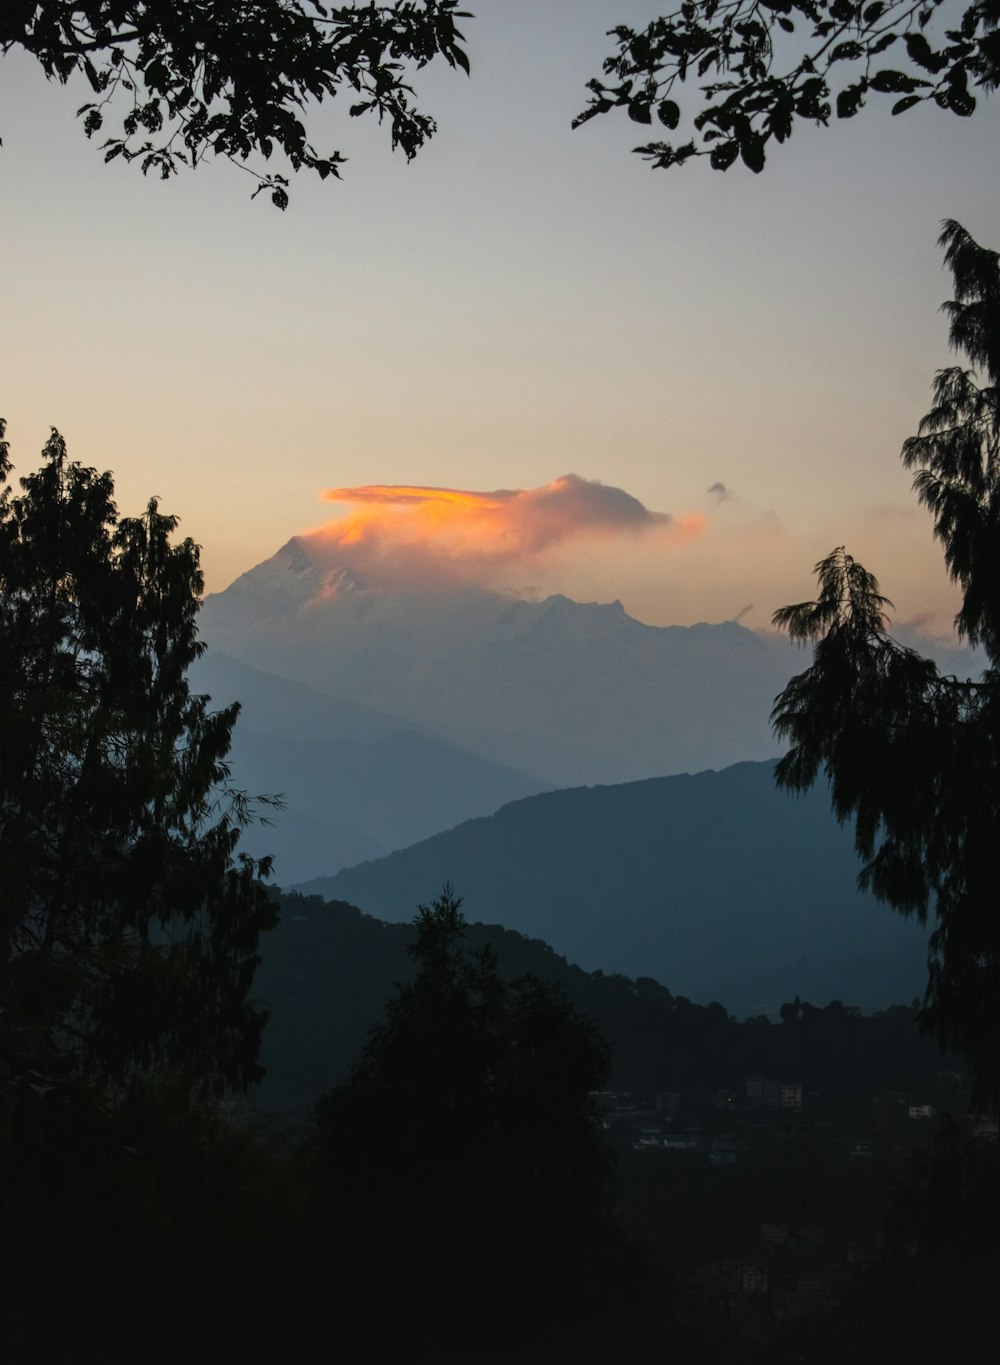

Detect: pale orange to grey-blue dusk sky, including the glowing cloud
[0, 0, 1000, 632]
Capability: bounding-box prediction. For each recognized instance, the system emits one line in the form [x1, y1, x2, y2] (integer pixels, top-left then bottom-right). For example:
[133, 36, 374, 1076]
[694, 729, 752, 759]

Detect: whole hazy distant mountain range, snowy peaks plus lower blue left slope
[199, 536, 975, 906]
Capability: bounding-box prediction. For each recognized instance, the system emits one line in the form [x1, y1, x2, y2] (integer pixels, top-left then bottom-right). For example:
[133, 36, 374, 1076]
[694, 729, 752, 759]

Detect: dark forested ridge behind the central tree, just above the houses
[254, 895, 941, 1110]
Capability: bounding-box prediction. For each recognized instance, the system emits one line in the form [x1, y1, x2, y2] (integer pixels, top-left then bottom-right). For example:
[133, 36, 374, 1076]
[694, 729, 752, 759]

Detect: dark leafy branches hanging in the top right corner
[574, 0, 1000, 172]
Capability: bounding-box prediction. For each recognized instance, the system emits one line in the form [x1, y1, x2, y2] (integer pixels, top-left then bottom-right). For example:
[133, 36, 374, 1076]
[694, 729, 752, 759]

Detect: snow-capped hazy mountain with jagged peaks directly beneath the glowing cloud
[201, 536, 804, 786]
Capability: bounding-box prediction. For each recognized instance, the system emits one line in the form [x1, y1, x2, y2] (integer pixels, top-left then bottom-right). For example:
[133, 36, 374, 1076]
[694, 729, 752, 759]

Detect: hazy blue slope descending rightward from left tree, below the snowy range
[190, 651, 546, 885]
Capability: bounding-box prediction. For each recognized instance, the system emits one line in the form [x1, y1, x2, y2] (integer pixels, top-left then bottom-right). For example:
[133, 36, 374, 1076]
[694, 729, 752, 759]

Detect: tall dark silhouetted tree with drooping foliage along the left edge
[0, 427, 276, 1092]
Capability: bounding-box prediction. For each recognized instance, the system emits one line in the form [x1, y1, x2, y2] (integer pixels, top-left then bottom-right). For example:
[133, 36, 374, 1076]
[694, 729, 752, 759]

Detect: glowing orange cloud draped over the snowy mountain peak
[310, 474, 704, 591]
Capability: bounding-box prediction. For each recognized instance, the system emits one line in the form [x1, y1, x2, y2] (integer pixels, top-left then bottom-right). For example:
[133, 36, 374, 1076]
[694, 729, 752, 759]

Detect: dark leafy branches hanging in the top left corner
[0, 0, 469, 209]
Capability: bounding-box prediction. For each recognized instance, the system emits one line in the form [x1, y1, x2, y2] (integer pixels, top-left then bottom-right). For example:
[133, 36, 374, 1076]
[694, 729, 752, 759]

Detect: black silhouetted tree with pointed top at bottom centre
[314, 887, 638, 1345]
